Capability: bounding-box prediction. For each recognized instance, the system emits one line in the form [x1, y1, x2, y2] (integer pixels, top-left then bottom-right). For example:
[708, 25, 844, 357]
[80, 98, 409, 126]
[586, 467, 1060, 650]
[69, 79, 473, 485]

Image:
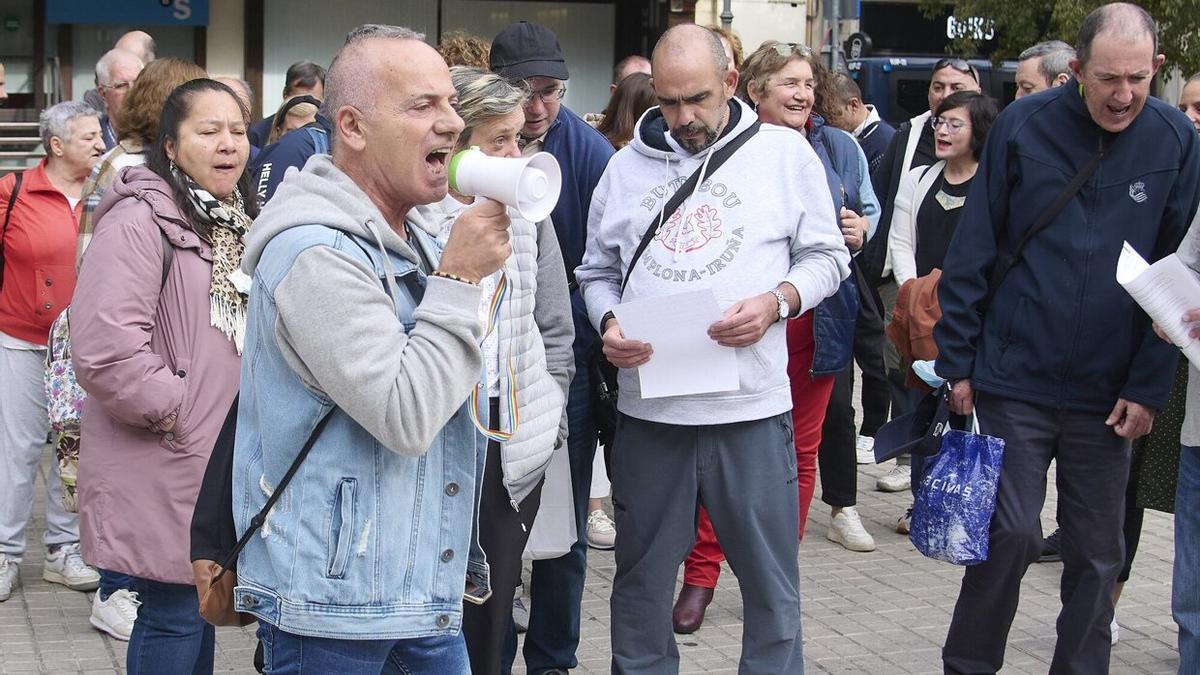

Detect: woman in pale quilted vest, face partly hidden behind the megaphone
[425, 66, 575, 675]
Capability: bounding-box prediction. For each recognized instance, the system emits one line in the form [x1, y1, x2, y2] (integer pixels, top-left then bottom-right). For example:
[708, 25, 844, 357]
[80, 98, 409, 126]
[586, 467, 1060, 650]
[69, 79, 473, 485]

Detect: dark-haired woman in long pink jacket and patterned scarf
[71, 79, 254, 675]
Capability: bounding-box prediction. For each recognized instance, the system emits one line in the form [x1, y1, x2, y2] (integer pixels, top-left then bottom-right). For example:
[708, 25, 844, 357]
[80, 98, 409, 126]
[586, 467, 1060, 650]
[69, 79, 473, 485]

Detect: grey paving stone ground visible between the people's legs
[0, 449, 1178, 675]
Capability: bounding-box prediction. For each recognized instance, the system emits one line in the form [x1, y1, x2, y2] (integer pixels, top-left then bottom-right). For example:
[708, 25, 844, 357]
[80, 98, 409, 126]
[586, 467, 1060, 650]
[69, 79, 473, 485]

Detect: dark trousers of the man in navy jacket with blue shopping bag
[942, 394, 1130, 675]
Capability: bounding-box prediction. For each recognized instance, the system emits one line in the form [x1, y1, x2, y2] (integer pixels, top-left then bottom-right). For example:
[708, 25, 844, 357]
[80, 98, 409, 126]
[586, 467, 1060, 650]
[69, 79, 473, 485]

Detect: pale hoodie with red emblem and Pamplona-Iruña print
[575, 98, 850, 425]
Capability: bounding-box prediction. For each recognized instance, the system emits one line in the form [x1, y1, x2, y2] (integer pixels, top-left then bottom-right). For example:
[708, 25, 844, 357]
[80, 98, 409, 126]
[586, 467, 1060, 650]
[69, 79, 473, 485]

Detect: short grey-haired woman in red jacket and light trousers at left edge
[0, 101, 104, 602]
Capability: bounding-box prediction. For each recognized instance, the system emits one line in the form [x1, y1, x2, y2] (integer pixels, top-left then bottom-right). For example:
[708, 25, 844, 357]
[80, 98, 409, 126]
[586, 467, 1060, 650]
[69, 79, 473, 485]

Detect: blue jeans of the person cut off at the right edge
[1171, 446, 1200, 675]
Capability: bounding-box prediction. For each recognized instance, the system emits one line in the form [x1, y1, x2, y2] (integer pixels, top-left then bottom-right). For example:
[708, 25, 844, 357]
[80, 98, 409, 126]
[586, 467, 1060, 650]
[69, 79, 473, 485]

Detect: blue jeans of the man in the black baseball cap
[500, 343, 596, 675]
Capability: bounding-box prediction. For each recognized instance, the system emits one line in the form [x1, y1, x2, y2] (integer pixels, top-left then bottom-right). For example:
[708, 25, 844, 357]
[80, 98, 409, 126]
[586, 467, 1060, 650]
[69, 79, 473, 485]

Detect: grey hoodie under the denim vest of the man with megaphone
[242, 155, 482, 455]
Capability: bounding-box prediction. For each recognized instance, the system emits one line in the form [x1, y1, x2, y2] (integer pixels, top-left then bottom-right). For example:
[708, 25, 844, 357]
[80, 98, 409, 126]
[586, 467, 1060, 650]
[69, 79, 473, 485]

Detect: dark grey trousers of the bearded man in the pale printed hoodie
[611, 412, 804, 675]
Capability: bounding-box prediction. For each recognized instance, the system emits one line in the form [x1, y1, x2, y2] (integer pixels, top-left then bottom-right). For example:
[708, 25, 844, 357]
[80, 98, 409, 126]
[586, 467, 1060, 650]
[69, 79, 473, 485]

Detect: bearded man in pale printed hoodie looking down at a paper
[576, 25, 850, 675]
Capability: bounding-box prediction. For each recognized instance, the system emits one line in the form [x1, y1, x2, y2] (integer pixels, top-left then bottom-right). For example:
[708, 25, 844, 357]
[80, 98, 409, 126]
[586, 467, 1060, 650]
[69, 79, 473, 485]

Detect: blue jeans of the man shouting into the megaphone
[258, 621, 470, 675]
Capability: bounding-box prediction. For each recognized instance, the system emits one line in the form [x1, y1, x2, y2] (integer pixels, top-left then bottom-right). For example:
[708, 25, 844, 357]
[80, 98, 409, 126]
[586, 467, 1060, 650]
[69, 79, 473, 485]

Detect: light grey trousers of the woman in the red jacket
[0, 347, 79, 560]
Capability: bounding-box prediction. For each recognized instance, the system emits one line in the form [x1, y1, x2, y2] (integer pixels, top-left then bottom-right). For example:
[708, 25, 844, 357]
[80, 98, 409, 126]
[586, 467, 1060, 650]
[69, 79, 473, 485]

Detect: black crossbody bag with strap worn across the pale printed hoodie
[588, 121, 762, 450]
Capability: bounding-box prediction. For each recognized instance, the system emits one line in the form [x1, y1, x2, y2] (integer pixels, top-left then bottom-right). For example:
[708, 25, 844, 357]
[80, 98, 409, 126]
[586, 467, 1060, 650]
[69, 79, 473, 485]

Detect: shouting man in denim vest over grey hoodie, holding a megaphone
[233, 25, 510, 673]
